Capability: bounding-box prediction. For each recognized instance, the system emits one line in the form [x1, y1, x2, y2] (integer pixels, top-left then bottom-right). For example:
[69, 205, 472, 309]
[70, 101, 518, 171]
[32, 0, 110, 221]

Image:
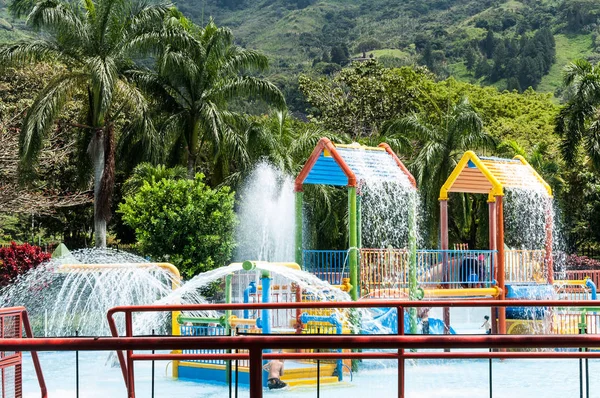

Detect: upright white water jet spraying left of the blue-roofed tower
[235, 162, 295, 261]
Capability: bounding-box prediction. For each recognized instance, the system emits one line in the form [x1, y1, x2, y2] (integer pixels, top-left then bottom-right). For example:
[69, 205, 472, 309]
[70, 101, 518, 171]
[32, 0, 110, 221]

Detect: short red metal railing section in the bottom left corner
[0, 307, 48, 398]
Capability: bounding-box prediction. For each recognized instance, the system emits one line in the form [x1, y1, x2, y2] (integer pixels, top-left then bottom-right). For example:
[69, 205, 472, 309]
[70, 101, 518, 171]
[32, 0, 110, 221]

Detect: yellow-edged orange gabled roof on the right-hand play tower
[440, 151, 552, 201]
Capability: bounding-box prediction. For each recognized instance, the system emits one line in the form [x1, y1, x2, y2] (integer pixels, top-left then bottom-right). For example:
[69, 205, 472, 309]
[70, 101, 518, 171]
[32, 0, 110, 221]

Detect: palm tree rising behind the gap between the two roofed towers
[386, 98, 496, 241]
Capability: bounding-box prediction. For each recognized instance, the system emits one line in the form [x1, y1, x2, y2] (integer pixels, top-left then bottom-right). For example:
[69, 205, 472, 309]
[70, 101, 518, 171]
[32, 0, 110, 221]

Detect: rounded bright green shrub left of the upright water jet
[118, 174, 236, 277]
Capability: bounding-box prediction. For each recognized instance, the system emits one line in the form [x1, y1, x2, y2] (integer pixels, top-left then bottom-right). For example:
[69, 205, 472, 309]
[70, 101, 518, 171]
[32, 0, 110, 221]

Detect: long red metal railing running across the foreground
[103, 300, 600, 398]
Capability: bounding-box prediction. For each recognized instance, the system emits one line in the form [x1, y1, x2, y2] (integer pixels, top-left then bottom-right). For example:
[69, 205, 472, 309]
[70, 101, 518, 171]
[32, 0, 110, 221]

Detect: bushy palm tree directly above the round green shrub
[133, 17, 285, 185]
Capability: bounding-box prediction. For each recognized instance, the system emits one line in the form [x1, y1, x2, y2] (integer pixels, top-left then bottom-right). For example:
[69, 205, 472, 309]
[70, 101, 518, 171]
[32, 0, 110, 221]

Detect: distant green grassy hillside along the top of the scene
[0, 0, 600, 96]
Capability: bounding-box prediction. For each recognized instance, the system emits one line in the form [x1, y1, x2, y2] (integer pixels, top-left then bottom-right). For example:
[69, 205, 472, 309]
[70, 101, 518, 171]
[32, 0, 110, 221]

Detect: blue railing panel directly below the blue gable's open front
[302, 250, 350, 285]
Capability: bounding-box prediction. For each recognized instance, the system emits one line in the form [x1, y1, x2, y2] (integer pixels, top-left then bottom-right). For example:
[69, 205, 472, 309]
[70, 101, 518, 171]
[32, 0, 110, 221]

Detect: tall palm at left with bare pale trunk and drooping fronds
[0, 0, 176, 247]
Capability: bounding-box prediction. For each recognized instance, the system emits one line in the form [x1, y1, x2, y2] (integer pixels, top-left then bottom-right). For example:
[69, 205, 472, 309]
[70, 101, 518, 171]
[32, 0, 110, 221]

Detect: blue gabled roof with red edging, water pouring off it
[295, 138, 416, 191]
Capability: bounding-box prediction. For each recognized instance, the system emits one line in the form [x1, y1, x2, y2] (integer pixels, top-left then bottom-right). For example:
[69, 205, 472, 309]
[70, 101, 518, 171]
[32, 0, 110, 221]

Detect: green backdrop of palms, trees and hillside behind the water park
[0, 0, 600, 275]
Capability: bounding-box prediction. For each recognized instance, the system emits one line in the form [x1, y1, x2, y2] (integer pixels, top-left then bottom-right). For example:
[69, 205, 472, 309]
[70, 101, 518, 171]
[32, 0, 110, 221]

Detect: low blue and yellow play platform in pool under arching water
[173, 261, 349, 386]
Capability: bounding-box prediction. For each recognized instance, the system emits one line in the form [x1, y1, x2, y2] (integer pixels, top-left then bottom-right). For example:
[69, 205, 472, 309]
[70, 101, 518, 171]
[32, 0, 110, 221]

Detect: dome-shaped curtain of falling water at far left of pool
[0, 249, 211, 336]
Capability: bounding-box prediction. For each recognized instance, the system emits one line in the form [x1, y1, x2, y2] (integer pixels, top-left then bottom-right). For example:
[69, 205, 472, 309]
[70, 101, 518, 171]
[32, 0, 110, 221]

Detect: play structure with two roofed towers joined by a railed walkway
[295, 138, 595, 334]
